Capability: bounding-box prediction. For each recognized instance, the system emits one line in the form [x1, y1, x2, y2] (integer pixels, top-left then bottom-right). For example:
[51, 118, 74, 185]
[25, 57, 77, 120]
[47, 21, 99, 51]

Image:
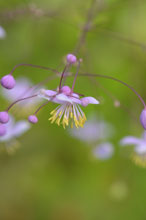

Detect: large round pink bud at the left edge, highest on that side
[1, 74, 16, 89]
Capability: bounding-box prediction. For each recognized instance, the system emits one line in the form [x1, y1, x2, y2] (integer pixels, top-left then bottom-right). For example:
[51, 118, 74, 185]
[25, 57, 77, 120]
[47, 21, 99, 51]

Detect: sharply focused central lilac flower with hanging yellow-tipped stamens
[39, 86, 99, 128]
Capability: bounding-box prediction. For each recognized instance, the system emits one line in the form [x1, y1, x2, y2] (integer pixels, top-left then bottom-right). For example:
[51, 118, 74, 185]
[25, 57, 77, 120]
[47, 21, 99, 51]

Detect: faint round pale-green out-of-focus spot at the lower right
[109, 181, 128, 201]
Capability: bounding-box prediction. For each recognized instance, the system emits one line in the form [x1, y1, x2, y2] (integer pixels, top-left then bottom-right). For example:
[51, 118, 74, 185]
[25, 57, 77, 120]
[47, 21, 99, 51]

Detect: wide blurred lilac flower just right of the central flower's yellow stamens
[69, 116, 113, 143]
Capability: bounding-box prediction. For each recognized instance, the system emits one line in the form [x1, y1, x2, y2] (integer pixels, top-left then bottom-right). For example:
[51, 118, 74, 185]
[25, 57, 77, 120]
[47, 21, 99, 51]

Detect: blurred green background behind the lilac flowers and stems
[0, 0, 146, 220]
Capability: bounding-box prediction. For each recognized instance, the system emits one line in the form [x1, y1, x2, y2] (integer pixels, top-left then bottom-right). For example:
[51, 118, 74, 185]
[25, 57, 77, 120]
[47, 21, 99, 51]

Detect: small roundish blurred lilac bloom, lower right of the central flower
[93, 142, 114, 160]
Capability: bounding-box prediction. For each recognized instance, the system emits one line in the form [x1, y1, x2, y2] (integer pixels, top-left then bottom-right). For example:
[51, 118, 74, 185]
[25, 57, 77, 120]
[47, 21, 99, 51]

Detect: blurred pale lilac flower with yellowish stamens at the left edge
[0, 116, 30, 152]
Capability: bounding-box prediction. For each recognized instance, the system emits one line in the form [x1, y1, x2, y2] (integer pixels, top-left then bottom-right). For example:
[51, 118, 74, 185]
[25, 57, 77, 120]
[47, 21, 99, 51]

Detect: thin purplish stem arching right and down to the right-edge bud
[78, 73, 146, 108]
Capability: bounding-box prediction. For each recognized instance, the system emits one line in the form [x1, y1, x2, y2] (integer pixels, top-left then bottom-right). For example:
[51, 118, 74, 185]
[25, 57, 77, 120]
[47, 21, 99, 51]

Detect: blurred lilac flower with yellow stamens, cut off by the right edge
[120, 131, 146, 167]
